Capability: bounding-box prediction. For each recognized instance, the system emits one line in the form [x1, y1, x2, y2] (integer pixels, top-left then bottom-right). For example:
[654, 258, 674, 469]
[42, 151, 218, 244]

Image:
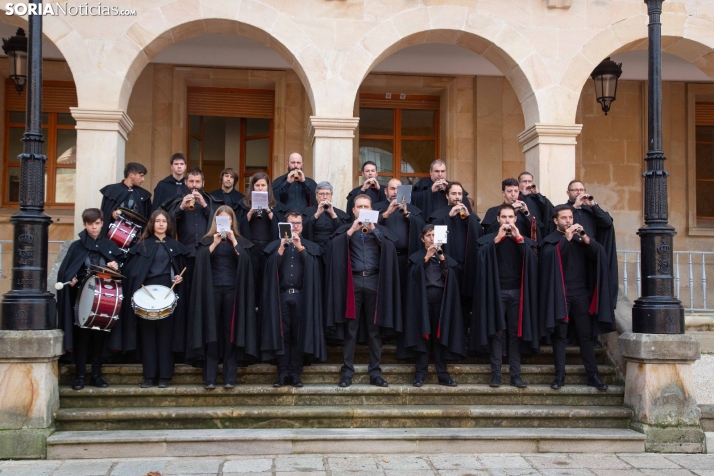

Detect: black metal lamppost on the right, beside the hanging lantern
[632, 0, 684, 334]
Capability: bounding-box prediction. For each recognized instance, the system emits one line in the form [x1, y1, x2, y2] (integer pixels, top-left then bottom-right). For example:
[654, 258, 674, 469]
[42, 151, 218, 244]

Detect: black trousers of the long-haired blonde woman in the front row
[203, 286, 238, 384]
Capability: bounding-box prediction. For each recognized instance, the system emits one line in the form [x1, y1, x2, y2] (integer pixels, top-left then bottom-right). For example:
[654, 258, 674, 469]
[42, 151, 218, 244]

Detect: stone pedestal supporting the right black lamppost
[619, 332, 704, 453]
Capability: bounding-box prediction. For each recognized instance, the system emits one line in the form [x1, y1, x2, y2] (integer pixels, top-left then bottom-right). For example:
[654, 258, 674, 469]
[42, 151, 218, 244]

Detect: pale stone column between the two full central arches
[309, 116, 359, 210]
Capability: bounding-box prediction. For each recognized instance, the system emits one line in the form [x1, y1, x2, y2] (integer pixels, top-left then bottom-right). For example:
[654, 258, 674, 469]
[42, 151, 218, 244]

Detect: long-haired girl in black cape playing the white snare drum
[110, 210, 189, 388]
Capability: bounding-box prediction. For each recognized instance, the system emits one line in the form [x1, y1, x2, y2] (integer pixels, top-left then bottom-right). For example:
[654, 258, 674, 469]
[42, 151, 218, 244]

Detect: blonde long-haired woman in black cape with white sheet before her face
[186, 205, 258, 390]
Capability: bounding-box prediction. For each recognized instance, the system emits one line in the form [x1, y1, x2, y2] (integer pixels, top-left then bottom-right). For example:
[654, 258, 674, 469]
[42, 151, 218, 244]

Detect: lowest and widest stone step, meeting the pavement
[47, 428, 644, 459]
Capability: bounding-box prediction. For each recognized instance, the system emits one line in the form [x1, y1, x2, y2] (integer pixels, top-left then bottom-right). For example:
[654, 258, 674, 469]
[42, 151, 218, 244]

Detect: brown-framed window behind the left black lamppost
[2, 80, 77, 208]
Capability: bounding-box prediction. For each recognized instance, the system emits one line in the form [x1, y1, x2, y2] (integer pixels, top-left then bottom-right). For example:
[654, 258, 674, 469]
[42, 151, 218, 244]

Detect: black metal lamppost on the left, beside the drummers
[0, 0, 57, 330]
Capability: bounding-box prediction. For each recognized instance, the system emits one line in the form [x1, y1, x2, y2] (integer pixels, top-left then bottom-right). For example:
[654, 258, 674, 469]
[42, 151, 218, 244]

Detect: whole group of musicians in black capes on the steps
[57, 153, 617, 390]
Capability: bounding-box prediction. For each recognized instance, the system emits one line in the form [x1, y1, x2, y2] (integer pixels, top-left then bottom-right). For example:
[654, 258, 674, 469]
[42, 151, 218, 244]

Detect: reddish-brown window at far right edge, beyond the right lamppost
[695, 103, 714, 224]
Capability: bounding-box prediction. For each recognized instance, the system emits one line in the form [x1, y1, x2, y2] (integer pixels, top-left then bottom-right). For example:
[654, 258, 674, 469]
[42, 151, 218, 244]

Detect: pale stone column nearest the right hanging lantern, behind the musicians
[518, 124, 583, 205]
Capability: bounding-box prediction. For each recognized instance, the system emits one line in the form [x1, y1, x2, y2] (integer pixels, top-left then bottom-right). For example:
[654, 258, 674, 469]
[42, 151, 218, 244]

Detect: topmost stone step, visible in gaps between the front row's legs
[60, 363, 617, 385]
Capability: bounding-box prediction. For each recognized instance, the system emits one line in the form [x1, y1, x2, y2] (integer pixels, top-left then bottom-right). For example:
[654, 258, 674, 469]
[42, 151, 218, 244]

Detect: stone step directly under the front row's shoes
[60, 384, 624, 409]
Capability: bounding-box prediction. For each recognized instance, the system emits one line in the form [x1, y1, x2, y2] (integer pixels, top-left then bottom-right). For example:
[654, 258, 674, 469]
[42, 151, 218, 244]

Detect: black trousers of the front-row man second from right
[489, 289, 521, 378]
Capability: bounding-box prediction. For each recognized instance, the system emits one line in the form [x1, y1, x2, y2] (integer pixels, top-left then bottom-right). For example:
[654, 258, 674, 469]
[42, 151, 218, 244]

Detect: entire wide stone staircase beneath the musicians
[48, 346, 644, 457]
